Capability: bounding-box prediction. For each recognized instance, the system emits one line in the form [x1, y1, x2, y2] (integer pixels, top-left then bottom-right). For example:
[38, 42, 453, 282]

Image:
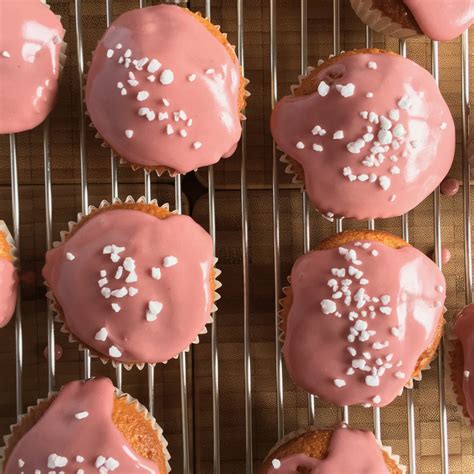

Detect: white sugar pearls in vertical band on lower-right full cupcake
[320, 242, 406, 404]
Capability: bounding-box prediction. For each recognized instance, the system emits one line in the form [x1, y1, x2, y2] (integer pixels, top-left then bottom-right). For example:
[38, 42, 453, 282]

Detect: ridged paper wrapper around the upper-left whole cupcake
[82, 7, 251, 178]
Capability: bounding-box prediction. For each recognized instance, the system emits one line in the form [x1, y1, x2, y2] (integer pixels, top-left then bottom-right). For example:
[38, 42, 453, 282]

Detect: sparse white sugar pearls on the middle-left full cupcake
[66, 244, 178, 358]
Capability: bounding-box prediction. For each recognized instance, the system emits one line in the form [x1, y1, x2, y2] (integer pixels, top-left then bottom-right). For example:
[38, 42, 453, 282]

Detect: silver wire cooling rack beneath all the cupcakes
[2, 0, 472, 474]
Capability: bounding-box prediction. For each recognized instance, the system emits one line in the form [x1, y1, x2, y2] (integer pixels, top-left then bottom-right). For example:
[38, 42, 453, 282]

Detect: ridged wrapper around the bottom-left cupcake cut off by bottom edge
[0, 388, 171, 473]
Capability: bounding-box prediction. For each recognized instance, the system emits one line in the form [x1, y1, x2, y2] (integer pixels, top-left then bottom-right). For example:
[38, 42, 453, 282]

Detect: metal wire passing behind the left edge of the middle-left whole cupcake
[43, 118, 56, 394]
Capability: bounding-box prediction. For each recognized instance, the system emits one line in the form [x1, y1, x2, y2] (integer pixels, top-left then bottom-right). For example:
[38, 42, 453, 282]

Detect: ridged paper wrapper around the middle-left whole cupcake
[44, 196, 222, 370]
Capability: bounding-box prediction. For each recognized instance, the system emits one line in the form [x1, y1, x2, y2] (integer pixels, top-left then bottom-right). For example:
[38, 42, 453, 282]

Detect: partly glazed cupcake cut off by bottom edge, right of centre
[259, 424, 406, 474]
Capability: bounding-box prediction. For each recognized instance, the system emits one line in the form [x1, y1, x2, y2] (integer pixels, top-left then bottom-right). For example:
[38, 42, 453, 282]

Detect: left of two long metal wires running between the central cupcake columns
[237, 0, 253, 473]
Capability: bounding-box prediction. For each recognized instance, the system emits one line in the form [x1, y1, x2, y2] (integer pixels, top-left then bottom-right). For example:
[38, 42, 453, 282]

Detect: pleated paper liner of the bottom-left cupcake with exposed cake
[0, 388, 171, 473]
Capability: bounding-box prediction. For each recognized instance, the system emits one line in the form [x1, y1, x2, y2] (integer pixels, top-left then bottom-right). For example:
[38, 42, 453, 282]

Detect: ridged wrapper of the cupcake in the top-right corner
[351, 0, 420, 39]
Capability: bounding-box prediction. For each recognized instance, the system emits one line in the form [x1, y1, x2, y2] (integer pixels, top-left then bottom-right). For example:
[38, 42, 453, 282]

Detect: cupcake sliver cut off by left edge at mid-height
[0, 221, 18, 328]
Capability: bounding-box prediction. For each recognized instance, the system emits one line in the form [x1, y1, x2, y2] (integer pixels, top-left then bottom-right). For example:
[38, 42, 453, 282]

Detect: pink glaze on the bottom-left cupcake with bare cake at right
[5, 378, 164, 474]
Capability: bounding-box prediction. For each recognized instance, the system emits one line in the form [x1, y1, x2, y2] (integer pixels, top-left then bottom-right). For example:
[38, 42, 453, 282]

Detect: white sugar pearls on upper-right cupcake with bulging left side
[295, 61, 447, 202]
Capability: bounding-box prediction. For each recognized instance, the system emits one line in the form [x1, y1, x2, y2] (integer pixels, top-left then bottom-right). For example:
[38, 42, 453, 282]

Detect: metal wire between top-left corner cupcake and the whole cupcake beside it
[74, 0, 91, 379]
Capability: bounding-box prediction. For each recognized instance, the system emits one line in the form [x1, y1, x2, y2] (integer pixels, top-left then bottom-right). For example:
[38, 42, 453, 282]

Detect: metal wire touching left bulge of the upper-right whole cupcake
[270, 0, 285, 439]
